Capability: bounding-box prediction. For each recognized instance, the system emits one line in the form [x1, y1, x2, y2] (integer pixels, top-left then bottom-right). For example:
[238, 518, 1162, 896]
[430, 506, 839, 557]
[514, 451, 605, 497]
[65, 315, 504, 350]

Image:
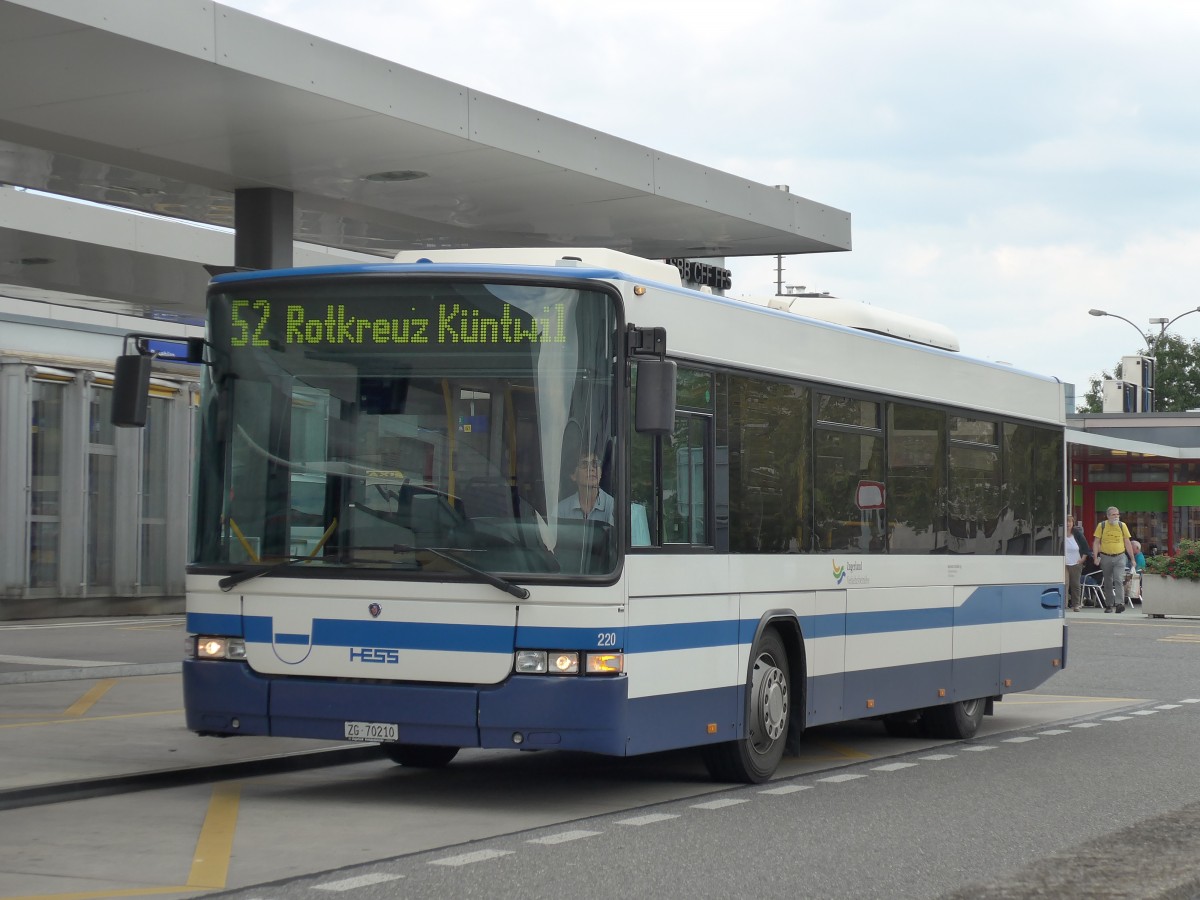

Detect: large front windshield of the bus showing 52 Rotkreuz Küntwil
[193, 278, 620, 578]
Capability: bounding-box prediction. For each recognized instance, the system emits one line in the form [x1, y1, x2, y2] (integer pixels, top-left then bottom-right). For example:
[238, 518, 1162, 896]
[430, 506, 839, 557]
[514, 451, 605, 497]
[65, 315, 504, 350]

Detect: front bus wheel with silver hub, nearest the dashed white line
[702, 629, 792, 785]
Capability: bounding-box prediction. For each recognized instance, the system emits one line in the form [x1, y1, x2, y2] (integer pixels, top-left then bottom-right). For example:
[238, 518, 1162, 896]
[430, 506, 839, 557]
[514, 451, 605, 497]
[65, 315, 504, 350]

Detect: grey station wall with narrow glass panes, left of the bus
[0, 360, 196, 619]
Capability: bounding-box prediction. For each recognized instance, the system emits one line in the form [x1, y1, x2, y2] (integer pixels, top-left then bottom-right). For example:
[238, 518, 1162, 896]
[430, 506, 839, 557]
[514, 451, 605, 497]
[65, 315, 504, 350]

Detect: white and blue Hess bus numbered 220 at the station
[117, 250, 1066, 782]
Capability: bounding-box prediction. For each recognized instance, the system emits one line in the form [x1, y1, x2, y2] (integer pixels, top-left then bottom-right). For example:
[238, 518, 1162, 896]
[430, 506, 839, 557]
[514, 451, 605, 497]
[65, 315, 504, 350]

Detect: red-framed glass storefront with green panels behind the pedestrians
[1070, 445, 1200, 557]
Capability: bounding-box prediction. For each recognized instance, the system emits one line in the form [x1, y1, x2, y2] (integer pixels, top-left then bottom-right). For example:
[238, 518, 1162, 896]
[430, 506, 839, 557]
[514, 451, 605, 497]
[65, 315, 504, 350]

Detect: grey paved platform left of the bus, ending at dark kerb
[0, 616, 378, 808]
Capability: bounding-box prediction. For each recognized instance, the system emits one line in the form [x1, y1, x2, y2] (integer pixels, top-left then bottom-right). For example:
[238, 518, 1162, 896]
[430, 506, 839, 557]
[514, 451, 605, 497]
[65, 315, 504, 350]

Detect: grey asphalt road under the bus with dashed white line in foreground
[0, 614, 1200, 900]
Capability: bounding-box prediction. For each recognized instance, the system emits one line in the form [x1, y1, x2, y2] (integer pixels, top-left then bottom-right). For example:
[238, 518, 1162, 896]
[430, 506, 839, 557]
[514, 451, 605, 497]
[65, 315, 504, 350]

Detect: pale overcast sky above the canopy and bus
[223, 0, 1200, 408]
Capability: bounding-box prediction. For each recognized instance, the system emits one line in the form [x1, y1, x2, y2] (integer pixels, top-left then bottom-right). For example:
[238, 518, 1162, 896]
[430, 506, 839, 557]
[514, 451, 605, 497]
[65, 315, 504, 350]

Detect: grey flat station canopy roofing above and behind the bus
[0, 0, 851, 321]
